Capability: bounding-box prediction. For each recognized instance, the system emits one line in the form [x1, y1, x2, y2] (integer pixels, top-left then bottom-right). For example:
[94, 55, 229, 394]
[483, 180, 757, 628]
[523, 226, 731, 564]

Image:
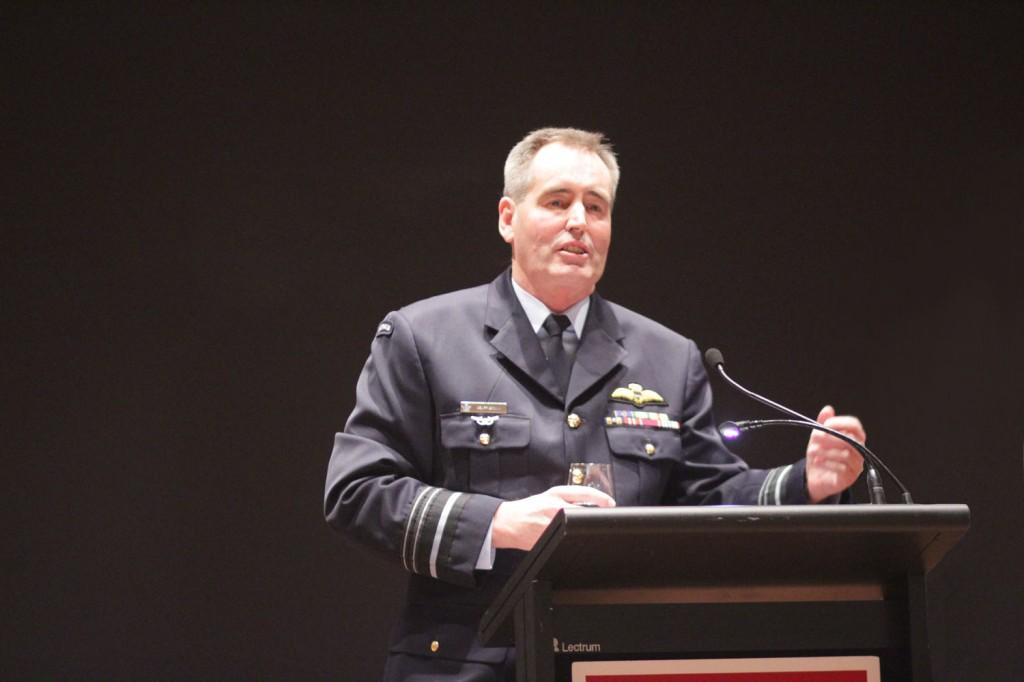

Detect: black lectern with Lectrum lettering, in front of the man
[480, 505, 970, 682]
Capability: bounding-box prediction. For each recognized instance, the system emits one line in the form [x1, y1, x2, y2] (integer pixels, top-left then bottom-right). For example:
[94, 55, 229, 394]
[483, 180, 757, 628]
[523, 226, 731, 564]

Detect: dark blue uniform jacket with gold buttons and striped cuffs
[325, 270, 807, 679]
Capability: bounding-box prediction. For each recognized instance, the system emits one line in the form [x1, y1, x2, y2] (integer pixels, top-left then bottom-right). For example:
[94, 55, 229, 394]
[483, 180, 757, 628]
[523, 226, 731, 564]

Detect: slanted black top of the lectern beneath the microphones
[481, 505, 970, 647]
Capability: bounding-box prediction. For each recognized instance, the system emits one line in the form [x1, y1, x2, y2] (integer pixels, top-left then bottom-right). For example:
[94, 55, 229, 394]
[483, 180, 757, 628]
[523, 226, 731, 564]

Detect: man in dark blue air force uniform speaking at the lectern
[325, 128, 865, 681]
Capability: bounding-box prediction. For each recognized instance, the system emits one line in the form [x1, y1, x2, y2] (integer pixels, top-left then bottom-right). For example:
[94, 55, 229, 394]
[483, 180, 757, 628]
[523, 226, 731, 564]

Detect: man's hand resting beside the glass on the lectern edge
[492, 485, 615, 550]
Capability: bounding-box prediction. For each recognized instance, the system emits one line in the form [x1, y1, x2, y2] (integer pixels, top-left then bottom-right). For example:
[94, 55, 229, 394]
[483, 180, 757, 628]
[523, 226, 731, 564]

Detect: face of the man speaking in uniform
[498, 142, 611, 312]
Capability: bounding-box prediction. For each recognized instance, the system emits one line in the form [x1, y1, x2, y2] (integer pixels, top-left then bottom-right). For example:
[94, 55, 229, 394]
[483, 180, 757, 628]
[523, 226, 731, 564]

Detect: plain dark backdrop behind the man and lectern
[0, 2, 1024, 681]
